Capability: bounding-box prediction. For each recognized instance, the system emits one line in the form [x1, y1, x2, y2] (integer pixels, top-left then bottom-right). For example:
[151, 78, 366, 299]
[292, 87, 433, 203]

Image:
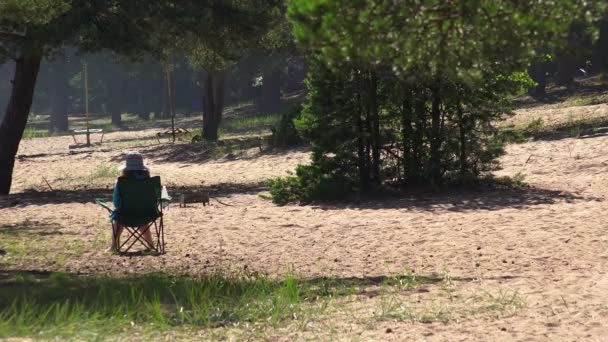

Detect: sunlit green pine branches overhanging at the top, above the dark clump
[288, 0, 582, 76]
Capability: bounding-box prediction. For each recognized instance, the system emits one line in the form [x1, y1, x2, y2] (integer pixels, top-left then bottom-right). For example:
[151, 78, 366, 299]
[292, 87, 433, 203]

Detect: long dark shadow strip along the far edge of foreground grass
[0, 270, 525, 300]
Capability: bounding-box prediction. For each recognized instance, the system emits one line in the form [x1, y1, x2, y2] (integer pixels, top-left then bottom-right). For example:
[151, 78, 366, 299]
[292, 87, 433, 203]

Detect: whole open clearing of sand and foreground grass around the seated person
[0, 99, 608, 341]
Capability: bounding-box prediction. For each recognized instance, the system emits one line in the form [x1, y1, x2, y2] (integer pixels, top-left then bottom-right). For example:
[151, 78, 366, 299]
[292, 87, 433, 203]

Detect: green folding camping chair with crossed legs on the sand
[96, 176, 167, 254]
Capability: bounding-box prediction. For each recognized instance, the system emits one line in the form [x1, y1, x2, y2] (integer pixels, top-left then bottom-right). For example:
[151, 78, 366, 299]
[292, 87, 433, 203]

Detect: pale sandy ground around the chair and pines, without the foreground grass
[0, 105, 608, 341]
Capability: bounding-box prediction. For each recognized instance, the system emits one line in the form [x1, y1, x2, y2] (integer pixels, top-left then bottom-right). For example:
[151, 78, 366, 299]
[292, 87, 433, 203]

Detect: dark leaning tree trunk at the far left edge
[0, 54, 42, 195]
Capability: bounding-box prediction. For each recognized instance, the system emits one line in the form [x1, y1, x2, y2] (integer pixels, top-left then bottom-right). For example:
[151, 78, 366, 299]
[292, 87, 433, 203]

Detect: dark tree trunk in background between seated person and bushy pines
[203, 70, 226, 141]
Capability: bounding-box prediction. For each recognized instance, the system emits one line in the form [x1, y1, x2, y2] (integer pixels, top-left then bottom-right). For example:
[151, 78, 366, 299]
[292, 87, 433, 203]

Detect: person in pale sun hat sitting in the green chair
[110, 153, 153, 249]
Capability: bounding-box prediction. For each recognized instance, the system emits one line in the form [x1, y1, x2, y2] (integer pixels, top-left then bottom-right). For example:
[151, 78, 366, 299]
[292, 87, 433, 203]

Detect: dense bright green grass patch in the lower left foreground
[0, 273, 313, 339]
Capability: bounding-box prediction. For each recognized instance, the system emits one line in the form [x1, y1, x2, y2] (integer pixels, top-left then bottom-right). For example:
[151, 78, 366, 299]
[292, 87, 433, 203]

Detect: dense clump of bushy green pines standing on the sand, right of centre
[279, 0, 579, 203]
